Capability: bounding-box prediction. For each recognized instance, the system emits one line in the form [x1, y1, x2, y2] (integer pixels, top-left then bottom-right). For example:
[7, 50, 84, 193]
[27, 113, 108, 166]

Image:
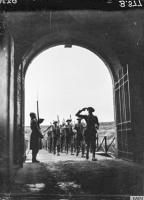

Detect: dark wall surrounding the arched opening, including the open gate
[0, 10, 144, 181]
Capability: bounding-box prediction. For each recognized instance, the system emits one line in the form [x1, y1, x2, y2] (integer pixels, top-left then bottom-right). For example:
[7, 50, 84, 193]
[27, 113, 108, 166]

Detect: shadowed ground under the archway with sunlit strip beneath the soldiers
[3, 150, 144, 200]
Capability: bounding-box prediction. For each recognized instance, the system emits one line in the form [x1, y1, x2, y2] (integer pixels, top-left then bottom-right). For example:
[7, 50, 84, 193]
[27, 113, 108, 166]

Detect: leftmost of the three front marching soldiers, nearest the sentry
[52, 121, 60, 156]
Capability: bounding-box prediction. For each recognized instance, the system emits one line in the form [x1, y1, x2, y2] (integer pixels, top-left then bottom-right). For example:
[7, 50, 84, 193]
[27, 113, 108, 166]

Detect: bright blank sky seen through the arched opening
[25, 45, 114, 125]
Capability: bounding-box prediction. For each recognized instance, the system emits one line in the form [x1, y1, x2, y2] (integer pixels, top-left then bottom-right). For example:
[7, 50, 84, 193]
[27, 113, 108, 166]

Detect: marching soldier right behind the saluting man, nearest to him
[74, 118, 84, 157]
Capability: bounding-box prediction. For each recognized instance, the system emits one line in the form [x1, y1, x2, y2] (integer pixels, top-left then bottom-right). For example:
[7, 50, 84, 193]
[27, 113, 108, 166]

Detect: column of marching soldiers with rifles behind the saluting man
[43, 118, 86, 157]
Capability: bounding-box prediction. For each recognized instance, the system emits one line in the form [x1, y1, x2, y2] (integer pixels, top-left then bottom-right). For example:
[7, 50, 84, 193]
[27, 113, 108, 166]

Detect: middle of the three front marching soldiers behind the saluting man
[65, 119, 74, 155]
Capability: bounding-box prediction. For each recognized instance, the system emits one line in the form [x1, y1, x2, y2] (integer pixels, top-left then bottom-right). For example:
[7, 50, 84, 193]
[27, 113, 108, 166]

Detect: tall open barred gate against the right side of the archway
[114, 65, 133, 160]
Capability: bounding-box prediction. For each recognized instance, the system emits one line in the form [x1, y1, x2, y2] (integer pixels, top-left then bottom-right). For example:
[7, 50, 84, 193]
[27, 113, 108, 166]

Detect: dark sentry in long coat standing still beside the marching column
[30, 113, 43, 162]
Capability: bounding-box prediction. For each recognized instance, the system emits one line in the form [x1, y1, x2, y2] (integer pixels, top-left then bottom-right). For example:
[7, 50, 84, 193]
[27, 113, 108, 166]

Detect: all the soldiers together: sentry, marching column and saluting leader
[30, 107, 99, 162]
